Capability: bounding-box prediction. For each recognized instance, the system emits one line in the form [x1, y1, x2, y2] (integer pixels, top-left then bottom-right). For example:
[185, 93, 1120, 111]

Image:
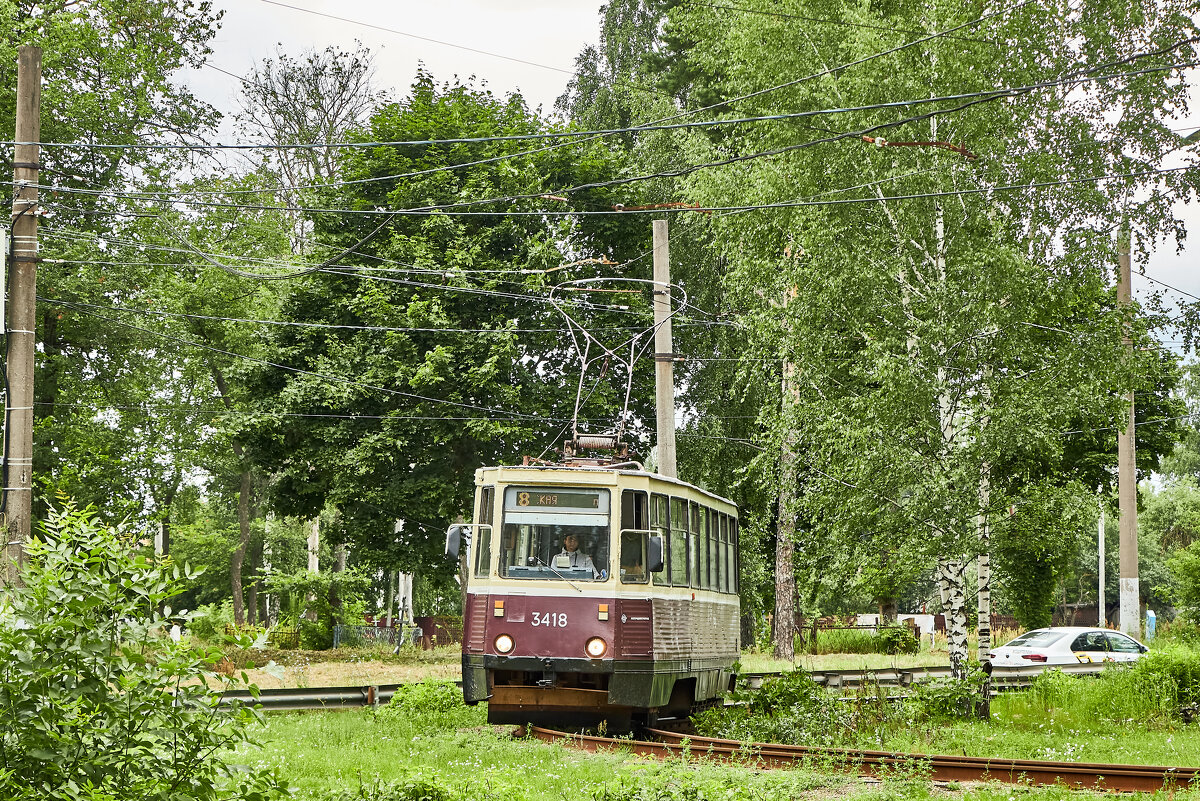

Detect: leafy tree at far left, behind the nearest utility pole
[0, 0, 220, 516]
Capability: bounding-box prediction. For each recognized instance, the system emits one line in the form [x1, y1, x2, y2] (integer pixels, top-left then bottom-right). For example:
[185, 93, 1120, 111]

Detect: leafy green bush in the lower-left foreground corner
[0, 507, 282, 801]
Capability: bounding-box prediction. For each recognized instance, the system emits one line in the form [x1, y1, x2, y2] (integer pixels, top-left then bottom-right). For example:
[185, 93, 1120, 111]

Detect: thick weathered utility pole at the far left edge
[0, 46, 42, 585]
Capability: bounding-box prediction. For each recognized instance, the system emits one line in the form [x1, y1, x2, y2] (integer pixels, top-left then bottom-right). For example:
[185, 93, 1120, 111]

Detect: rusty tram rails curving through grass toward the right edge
[528, 727, 1200, 793]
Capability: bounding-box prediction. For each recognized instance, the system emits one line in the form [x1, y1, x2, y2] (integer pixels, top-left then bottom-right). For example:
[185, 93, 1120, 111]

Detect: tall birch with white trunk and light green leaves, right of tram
[667, 0, 1196, 660]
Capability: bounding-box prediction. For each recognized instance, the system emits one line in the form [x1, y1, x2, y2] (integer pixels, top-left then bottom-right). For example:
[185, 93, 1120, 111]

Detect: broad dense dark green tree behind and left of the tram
[237, 73, 649, 570]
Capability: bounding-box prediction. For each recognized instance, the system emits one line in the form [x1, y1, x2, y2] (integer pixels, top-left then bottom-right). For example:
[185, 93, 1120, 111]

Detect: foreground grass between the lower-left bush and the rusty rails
[250, 705, 852, 801]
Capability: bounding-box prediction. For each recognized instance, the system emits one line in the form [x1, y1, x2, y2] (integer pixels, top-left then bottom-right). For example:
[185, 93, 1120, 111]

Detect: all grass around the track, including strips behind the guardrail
[225, 633, 1200, 801]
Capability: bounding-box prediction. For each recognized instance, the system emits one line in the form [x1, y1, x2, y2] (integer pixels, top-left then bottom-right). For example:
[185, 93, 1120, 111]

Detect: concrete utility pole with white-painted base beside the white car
[1117, 230, 1141, 636]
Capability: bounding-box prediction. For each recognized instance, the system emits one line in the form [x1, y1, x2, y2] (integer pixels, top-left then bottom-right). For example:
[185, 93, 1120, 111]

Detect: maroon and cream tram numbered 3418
[446, 463, 740, 729]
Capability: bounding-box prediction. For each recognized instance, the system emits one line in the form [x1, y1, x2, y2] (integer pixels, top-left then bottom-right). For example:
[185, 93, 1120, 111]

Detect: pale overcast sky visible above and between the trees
[184, 0, 1200, 326]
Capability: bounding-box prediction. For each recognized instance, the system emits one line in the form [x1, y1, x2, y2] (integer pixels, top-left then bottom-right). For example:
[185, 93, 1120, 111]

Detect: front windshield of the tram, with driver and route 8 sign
[500, 487, 610, 582]
